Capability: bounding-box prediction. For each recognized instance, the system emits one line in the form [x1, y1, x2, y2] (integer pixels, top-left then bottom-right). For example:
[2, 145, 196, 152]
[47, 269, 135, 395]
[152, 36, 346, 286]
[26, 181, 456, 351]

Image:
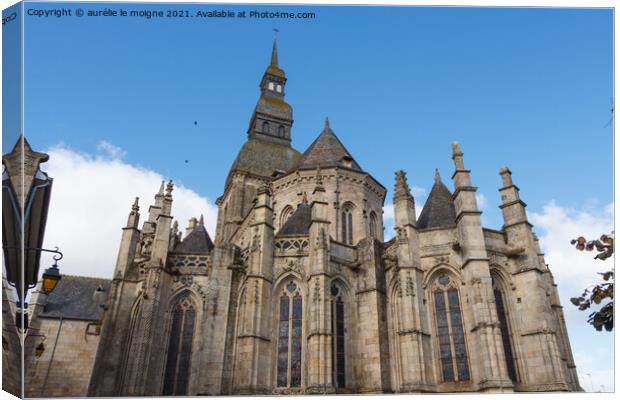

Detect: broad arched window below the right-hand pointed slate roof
[432, 275, 469, 382]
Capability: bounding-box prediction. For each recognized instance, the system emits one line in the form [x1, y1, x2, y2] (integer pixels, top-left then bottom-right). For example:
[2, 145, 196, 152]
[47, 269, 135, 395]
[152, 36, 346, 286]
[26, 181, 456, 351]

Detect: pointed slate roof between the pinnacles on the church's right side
[416, 177, 456, 229]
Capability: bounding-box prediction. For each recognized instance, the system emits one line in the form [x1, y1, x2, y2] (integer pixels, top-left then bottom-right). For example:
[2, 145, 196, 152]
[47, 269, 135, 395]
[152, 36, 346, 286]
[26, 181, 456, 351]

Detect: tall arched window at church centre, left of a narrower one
[277, 281, 302, 387]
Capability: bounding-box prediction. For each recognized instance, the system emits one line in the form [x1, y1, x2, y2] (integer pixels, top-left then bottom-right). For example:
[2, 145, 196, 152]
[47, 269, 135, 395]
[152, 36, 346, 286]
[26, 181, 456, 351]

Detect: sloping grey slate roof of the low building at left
[40, 275, 112, 321]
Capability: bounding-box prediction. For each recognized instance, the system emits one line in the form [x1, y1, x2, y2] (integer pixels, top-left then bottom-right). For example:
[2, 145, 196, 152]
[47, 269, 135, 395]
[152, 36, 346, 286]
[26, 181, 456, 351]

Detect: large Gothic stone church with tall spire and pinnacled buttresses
[23, 41, 581, 397]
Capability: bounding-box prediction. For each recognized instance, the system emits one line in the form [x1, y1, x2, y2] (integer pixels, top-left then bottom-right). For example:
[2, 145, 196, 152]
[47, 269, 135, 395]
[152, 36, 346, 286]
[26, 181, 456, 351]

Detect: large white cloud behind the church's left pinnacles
[41, 142, 217, 278]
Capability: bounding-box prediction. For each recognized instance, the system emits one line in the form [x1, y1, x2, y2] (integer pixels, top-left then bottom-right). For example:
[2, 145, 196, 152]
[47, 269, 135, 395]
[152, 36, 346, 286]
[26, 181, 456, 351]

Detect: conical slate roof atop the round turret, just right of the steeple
[297, 121, 362, 172]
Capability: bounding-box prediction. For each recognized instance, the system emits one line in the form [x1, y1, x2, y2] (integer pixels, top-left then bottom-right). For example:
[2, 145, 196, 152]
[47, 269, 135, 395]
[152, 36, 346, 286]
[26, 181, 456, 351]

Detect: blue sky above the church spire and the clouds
[9, 3, 613, 394]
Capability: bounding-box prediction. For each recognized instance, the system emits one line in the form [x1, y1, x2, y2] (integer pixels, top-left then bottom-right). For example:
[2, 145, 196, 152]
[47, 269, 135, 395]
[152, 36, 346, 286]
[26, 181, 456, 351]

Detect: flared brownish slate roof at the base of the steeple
[227, 139, 300, 181]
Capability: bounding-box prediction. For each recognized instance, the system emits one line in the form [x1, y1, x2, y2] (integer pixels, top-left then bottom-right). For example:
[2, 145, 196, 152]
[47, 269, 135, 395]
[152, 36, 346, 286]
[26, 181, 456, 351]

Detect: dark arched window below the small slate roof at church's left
[163, 293, 196, 396]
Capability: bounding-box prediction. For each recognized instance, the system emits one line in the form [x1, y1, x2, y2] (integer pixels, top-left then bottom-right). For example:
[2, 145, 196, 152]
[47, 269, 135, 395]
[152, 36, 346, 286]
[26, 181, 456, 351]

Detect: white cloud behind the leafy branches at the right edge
[529, 201, 614, 392]
